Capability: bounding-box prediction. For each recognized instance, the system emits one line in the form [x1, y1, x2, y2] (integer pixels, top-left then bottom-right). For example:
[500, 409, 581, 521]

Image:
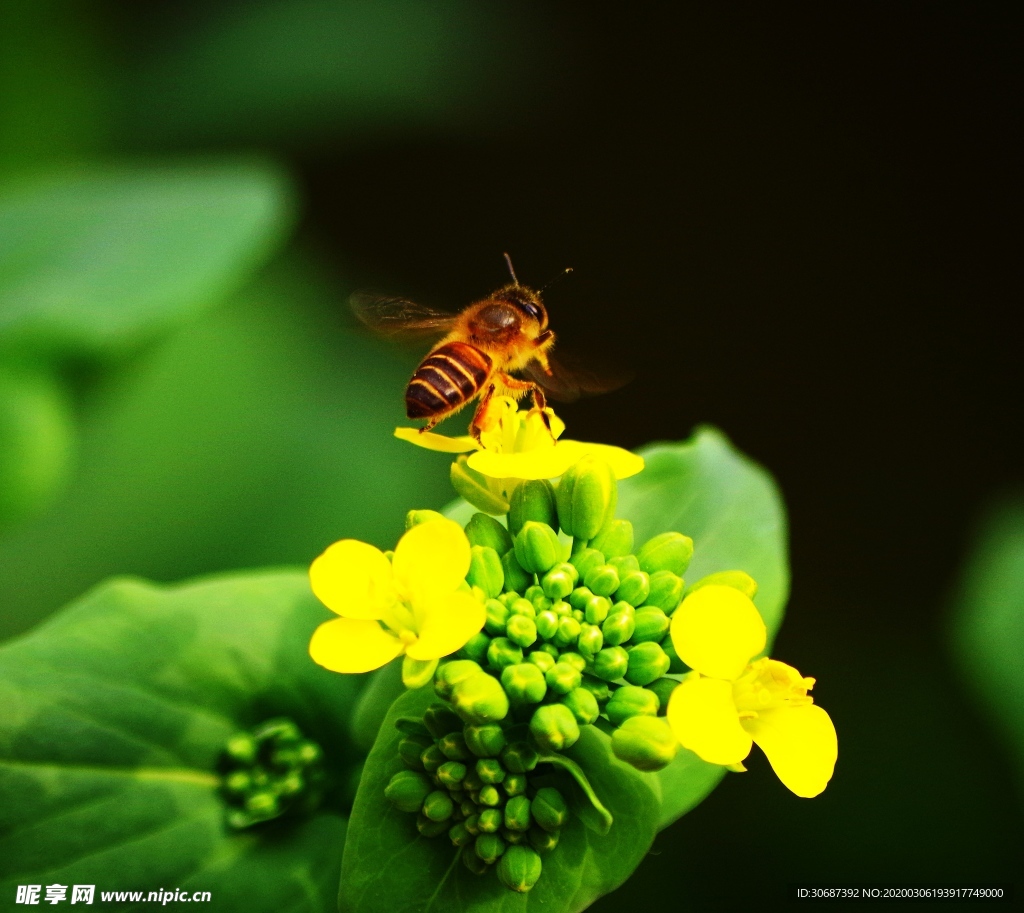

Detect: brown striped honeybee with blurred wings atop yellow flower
[350, 254, 625, 441]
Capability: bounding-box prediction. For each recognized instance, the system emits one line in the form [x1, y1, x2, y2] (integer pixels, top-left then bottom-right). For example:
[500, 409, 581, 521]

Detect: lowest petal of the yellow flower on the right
[742, 704, 839, 798]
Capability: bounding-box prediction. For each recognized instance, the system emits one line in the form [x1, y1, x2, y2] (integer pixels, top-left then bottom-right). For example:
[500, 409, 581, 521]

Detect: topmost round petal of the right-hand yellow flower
[672, 584, 768, 682]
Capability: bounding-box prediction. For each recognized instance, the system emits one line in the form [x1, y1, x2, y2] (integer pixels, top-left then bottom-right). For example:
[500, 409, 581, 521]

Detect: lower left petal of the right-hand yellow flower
[668, 672, 752, 766]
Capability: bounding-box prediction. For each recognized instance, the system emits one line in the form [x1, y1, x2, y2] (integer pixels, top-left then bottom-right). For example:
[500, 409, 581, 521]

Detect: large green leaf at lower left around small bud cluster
[0, 571, 357, 911]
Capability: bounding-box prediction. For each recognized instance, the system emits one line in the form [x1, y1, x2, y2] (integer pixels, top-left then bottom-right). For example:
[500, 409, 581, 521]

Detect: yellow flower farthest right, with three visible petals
[668, 585, 839, 798]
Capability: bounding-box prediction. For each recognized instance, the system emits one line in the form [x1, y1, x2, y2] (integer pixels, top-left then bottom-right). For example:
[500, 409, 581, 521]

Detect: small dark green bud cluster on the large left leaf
[220, 718, 325, 830]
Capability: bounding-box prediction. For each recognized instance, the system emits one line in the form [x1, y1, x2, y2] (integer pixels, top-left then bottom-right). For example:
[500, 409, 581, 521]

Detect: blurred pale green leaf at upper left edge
[0, 163, 291, 356]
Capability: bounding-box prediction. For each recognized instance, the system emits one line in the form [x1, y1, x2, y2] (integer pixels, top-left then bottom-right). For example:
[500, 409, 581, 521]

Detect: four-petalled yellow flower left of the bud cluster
[309, 519, 486, 672]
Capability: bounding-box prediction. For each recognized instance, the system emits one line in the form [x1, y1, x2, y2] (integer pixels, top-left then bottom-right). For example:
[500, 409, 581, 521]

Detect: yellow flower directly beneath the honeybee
[394, 396, 643, 488]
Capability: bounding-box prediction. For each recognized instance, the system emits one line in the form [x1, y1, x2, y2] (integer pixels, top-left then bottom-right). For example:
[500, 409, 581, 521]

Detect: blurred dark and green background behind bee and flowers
[0, 0, 1024, 911]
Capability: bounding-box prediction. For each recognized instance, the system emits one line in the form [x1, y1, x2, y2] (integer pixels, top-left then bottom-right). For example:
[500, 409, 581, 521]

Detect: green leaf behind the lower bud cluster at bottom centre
[339, 688, 658, 913]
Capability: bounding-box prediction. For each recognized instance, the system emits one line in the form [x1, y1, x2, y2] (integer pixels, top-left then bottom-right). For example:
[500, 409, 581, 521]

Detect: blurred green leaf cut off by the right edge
[949, 497, 1024, 788]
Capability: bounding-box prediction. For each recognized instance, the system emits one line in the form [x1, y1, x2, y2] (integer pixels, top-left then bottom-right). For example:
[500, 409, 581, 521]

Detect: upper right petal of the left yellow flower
[391, 520, 470, 601]
